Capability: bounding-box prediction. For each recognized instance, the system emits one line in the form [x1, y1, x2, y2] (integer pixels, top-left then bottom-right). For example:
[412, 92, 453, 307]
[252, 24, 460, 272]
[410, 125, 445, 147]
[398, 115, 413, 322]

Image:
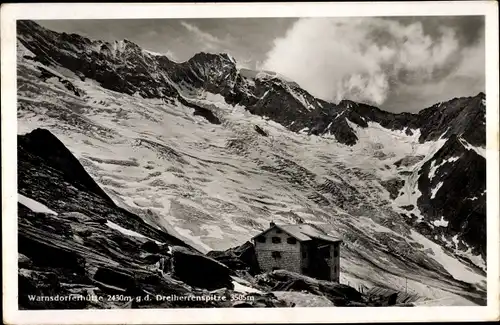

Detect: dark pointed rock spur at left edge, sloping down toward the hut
[17, 129, 191, 246]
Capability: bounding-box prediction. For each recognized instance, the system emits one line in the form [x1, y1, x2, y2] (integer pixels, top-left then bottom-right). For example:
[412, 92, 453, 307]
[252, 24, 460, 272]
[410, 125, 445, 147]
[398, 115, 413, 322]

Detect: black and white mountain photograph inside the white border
[2, 2, 498, 321]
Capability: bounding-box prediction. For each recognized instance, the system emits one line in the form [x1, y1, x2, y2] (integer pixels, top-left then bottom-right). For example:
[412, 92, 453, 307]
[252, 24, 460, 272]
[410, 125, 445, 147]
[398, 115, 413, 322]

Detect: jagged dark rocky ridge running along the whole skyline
[18, 21, 486, 145]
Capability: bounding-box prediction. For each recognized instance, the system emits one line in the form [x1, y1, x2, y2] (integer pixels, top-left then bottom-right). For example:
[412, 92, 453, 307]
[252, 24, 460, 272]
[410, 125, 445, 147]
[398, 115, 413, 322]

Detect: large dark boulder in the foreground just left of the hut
[172, 246, 233, 290]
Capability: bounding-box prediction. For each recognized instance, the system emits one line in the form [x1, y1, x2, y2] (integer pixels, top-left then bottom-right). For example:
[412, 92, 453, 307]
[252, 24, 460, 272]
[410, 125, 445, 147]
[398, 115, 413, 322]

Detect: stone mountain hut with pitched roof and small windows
[252, 222, 342, 282]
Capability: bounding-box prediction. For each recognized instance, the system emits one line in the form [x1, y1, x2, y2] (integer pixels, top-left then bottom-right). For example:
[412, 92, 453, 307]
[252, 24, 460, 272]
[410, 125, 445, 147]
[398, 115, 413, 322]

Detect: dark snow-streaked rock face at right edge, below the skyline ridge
[417, 135, 486, 256]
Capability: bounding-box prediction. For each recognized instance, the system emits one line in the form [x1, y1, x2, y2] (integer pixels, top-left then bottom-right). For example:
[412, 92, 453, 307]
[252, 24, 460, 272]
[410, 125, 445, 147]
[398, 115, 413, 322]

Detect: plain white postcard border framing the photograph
[1, 1, 500, 324]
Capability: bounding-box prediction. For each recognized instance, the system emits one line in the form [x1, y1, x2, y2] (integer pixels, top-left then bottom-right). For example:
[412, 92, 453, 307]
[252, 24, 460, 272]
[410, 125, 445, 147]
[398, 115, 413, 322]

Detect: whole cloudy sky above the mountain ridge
[37, 16, 485, 113]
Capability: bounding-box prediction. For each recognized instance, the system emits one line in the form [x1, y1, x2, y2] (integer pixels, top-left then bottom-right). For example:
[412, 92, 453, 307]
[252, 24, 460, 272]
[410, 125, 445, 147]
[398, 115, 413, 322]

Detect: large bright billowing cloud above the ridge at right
[263, 18, 484, 108]
